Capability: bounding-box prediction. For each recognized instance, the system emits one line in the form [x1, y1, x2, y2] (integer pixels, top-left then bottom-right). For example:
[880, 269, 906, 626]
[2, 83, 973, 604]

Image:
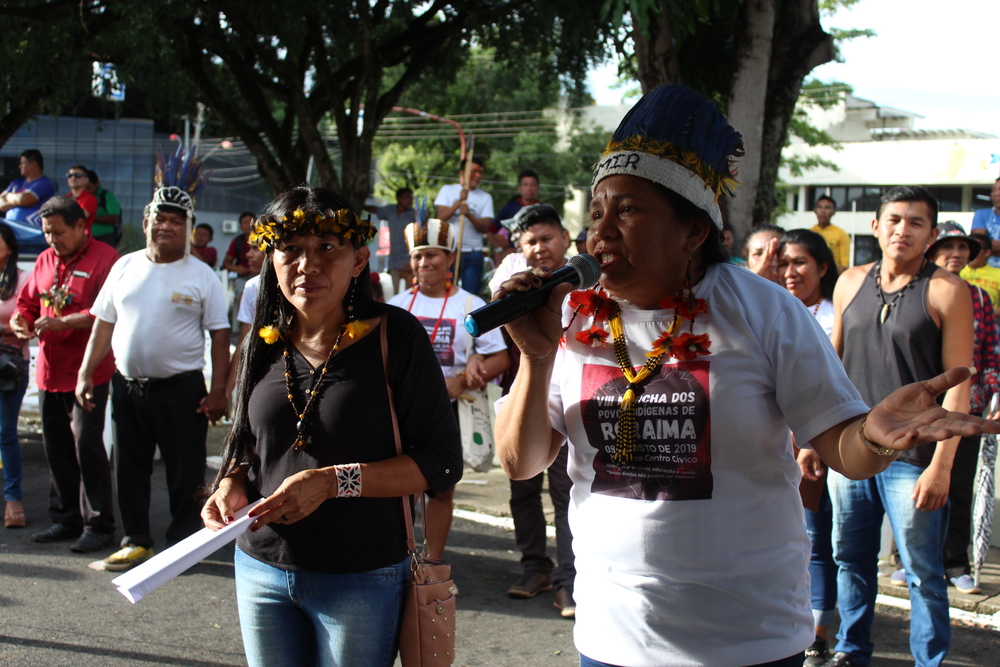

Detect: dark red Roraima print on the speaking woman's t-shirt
[581, 361, 713, 500]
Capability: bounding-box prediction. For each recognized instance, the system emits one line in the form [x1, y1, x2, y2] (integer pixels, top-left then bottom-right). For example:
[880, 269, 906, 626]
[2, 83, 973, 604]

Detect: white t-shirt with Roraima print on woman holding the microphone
[549, 264, 868, 667]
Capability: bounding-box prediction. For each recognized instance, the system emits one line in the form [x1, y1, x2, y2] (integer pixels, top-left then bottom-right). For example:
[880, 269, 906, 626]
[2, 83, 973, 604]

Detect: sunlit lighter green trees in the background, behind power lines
[375, 49, 607, 210]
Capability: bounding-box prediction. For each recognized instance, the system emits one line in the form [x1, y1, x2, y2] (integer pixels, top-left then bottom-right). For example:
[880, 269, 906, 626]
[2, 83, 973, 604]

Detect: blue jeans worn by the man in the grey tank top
[827, 461, 951, 667]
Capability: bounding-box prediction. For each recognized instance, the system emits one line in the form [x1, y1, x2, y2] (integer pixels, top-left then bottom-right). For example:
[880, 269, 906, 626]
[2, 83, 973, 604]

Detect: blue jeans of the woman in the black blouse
[235, 549, 409, 667]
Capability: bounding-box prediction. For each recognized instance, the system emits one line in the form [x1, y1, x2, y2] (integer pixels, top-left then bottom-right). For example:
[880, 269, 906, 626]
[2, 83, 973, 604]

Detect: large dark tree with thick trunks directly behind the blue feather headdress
[604, 0, 871, 237]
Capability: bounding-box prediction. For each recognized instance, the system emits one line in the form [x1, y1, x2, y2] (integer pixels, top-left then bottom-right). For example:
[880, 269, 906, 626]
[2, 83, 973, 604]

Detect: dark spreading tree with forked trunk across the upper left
[0, 0, 604, 211]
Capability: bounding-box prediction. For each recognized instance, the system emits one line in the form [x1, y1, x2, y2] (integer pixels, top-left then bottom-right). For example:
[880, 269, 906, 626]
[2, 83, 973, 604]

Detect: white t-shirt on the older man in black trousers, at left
[90, 250, 229, 378]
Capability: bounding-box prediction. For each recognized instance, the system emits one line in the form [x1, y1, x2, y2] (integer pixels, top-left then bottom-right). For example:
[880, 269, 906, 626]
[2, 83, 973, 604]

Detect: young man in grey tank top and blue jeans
[826, 187, 973, 667]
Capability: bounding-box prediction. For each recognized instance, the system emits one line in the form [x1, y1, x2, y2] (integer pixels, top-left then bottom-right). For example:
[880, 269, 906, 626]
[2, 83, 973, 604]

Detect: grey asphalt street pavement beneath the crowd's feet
[0, 414, 1000, 667]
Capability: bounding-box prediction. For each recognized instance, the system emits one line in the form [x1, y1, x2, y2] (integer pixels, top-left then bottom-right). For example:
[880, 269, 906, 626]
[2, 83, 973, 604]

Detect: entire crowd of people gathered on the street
[0, 85, 1000, 667]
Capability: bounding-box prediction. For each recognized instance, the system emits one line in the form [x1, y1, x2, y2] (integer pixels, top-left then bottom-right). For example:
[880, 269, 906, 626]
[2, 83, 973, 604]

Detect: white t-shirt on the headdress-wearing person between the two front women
[386, 288, 507, 377]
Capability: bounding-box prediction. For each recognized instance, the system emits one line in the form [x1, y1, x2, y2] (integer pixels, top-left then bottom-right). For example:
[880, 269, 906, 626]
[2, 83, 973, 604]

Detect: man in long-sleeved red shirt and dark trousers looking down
[10, 197, 118, 553]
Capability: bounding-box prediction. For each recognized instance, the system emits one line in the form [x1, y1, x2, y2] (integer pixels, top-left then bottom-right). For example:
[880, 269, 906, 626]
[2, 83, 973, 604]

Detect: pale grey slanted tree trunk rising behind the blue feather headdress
[724, 0, 776, 239]
